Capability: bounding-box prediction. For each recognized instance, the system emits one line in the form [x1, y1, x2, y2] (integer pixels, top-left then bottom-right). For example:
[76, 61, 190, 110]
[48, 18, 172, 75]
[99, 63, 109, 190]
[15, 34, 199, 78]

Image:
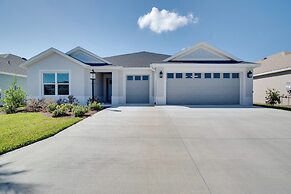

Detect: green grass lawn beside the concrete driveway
[0, 113, 81, 154]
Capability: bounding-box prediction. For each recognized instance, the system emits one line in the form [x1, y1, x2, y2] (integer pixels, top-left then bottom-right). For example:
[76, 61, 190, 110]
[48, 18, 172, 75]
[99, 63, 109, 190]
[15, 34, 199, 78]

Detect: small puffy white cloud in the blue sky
[137, 7, 199, 34]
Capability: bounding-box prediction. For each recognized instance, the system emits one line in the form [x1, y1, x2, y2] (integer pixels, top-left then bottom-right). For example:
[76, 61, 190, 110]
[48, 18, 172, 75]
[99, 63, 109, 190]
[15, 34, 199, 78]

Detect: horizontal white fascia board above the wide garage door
[151, 62, 260, 68]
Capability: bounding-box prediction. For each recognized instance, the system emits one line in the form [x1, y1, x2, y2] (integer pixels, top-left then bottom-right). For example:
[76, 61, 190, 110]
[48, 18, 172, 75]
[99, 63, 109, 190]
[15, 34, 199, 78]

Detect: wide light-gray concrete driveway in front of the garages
[0, 106, 291, 194]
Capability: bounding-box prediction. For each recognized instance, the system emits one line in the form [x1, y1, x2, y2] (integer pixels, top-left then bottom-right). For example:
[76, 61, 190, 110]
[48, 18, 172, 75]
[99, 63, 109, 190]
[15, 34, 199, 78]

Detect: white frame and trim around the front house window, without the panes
[40, 70, 72, 97]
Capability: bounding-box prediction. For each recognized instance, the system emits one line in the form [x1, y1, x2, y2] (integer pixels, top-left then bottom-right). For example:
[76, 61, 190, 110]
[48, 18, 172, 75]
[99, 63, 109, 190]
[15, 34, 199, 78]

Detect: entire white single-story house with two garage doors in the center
[21, 43, 259, 105]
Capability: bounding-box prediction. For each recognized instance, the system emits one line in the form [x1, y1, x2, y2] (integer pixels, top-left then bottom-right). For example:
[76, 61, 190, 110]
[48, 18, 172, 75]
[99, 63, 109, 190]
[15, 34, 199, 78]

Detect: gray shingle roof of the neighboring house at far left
[0, 54, 26, 75]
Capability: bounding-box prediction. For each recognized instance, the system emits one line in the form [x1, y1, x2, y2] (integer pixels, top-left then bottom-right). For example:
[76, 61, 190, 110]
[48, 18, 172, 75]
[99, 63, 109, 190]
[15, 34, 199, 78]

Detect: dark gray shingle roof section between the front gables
[104, 51, 170, 67]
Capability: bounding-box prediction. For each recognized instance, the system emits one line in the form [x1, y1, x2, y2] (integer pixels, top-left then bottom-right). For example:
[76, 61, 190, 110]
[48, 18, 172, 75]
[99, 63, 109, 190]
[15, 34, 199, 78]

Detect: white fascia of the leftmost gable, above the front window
[20, 47, 90, 68]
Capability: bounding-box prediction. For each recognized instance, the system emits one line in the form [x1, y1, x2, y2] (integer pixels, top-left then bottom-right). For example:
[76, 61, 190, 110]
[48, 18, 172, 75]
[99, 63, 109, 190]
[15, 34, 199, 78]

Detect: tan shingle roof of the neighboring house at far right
[254, 52, 291, 75]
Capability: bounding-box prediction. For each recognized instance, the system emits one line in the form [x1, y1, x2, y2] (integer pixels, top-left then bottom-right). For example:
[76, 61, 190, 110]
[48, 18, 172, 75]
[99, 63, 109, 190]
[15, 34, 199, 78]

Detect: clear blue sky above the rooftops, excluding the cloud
[0, 0, 291, 61]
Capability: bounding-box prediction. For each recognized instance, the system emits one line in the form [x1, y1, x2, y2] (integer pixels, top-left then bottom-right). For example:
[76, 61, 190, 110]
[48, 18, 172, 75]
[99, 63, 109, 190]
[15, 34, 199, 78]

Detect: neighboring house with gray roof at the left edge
[0, 54, 26, 105]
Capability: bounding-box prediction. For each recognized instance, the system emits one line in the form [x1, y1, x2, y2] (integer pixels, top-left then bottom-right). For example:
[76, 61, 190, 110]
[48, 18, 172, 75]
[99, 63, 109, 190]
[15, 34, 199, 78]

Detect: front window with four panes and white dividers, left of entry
[42, 73, 70, 96]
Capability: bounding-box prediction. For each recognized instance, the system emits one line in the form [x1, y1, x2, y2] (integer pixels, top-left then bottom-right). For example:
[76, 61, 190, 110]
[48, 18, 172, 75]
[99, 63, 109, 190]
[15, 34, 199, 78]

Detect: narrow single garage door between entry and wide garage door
[126, 75, 150, 104]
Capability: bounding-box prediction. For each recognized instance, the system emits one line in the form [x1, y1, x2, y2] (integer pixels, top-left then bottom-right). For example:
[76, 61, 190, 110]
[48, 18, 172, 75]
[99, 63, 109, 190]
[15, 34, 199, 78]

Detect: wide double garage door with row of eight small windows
[167, 73, 240, 105]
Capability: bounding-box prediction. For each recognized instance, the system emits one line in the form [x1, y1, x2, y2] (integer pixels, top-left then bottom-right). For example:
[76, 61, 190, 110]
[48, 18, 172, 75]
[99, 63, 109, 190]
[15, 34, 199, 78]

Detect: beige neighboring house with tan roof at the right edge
[254, 52, 291, 104]
